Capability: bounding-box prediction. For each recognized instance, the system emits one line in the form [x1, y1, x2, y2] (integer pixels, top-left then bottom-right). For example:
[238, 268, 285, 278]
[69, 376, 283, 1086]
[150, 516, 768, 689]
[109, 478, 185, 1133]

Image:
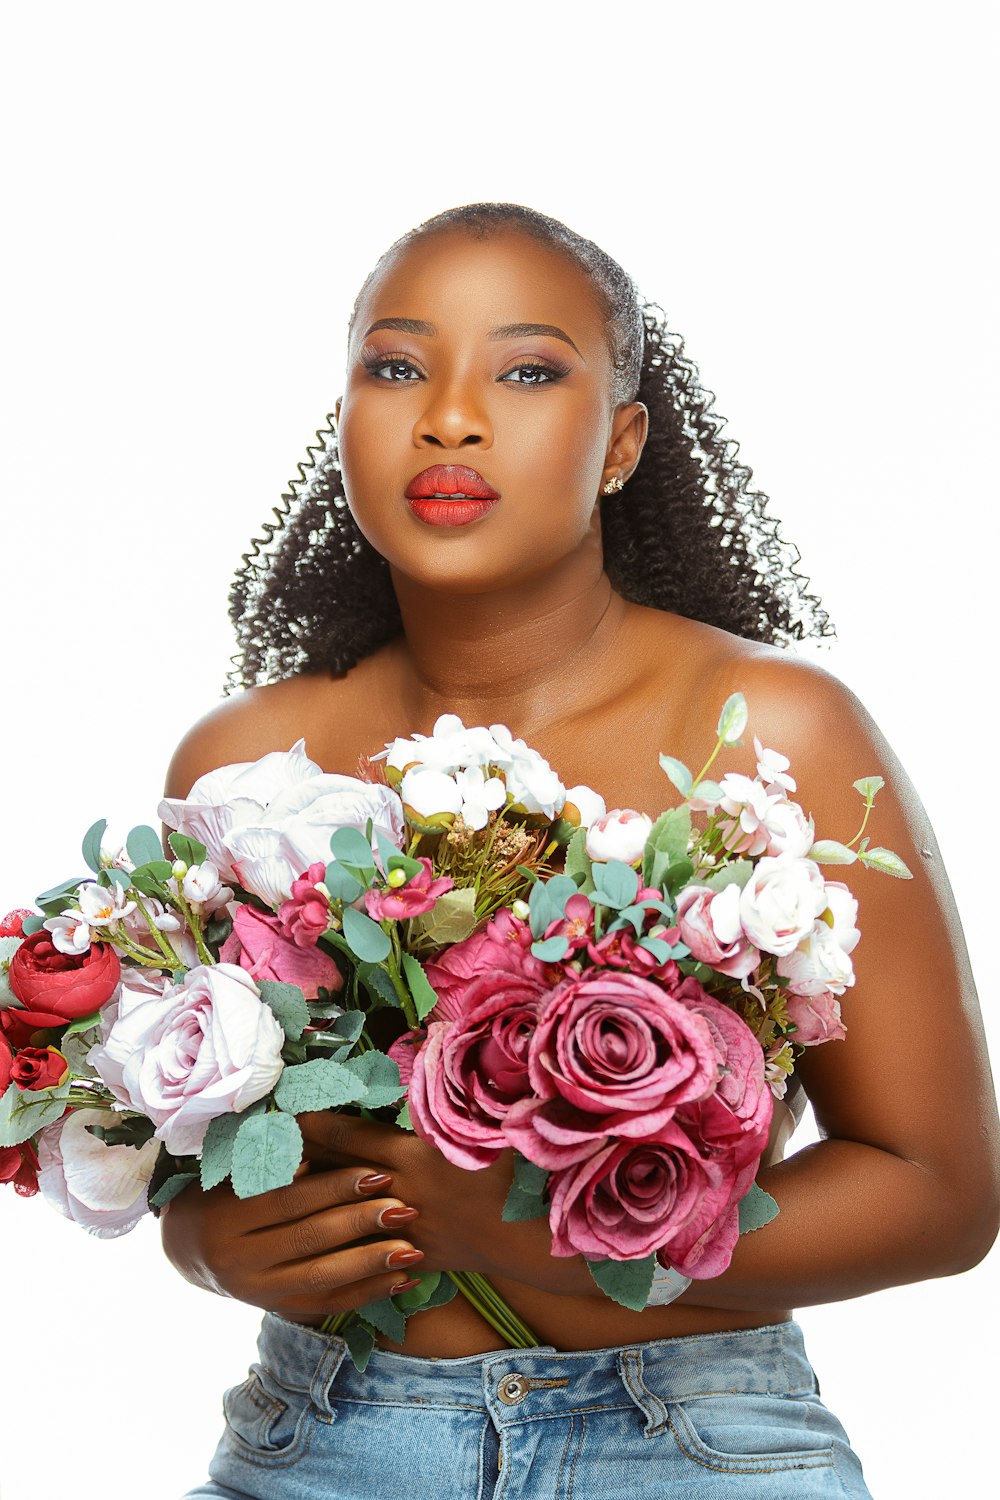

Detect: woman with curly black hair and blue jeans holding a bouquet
[163, 204, 999, 1500]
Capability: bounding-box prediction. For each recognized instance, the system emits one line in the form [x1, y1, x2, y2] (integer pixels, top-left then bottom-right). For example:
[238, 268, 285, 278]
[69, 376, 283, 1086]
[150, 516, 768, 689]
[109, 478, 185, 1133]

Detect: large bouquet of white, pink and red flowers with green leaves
[0, 693, 910, 1364]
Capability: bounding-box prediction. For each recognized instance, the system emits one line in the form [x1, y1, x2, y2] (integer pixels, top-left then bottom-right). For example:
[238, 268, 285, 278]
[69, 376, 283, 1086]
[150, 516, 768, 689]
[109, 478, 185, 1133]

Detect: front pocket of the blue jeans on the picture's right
[667, 1394, 840, 1493]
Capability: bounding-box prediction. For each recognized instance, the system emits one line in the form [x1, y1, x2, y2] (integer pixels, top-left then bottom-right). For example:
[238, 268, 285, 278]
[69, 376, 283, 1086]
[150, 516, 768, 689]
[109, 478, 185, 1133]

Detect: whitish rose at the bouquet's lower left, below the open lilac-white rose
[37, 1110, 160, 1239]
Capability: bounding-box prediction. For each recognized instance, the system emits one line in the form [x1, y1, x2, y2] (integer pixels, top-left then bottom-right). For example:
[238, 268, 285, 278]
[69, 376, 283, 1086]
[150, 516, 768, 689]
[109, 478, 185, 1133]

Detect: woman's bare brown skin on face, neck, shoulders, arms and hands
[162, 230, 1000, 1356]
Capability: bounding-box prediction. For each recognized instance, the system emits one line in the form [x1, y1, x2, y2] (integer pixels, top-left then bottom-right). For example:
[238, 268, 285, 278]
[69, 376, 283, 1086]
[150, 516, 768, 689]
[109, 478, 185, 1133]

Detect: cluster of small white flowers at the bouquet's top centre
[373, 714, 604, 830]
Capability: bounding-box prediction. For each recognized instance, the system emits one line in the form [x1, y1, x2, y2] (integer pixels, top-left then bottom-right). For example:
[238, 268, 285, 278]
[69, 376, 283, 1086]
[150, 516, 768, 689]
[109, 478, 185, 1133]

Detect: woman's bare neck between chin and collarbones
[393, 549, 628, 734]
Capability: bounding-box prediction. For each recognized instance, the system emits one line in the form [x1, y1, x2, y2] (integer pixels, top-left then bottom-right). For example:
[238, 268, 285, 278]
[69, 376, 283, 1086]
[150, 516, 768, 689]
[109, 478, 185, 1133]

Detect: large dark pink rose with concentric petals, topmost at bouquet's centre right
[528, 969, 718, 1137]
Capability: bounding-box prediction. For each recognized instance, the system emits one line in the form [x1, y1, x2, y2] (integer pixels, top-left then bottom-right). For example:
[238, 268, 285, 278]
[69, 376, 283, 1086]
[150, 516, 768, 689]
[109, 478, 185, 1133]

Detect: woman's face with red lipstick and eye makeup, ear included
[337, 228, 645, 593]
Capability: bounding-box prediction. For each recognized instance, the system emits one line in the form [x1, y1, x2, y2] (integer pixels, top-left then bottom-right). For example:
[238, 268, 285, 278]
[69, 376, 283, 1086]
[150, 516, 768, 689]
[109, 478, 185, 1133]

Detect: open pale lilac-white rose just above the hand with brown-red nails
[88, 963, 285, 1157]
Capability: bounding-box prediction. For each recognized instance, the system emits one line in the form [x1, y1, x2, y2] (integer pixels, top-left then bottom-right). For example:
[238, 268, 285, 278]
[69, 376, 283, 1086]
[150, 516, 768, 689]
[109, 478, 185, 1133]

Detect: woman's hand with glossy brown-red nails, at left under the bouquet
[160, 1166, 424, 1325]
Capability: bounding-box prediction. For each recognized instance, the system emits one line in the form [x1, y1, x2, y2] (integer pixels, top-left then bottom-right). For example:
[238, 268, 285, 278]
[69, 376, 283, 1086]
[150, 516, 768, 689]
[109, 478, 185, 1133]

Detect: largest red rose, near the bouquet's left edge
[0, 929, 121, 1046]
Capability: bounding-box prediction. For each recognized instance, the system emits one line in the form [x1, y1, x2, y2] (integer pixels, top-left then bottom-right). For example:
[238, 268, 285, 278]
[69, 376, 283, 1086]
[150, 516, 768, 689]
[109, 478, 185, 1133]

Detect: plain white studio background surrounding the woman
[0, 0, 1000, 1500]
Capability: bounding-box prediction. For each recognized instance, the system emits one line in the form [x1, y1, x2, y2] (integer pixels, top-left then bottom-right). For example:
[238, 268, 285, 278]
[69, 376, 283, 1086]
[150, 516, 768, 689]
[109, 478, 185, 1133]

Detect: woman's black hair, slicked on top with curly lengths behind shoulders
[226, 203, 834, 692]
